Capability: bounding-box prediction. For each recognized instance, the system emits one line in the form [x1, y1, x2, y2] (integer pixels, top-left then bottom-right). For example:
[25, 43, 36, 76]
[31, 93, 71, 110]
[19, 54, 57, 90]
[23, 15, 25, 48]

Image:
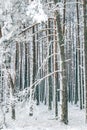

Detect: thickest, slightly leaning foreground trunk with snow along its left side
[54, 0, 68, 124]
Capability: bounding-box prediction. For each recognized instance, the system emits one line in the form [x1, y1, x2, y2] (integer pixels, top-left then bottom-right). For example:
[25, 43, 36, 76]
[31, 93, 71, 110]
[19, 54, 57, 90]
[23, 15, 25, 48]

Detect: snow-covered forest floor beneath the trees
[2, 104, 87, 130]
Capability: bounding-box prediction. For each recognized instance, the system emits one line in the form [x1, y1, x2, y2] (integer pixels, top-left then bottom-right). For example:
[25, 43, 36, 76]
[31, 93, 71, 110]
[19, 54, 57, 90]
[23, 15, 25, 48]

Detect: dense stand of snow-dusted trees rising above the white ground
[0, 0, 87, 127]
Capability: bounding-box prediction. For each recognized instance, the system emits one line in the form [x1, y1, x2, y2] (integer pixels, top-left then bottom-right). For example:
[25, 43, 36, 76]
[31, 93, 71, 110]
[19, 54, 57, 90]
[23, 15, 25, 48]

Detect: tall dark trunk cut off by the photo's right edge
[83, 0, 87, 123]
